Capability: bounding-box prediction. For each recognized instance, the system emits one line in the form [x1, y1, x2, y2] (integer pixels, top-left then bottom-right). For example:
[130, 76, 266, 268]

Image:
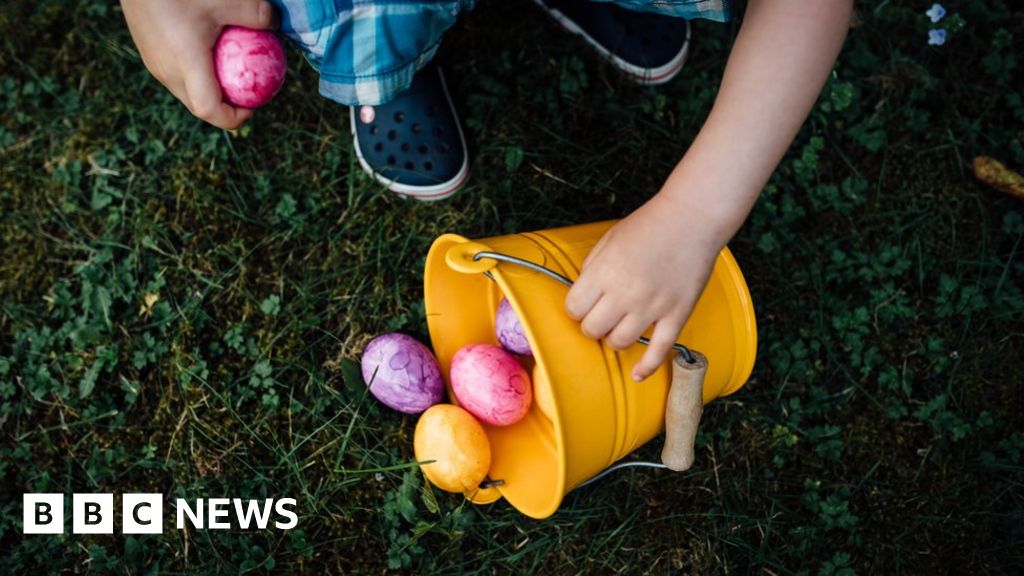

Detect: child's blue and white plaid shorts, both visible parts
[270, 0, 731, 106]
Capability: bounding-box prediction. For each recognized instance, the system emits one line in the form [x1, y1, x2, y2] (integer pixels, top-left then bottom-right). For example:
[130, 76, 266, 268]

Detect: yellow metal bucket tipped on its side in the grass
[424, 221, 757, 519]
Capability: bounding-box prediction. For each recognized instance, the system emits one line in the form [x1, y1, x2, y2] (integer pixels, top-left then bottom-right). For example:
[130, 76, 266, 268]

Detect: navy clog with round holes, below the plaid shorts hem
[350, 64, 469, 201]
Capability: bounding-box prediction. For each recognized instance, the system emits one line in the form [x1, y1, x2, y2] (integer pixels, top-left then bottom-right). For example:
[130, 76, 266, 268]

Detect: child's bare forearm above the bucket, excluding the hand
[658, 0, 853, 245]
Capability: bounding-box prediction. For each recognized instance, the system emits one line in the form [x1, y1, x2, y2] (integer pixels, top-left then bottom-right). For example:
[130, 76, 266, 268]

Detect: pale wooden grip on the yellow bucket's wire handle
[662, 349, 708, 471]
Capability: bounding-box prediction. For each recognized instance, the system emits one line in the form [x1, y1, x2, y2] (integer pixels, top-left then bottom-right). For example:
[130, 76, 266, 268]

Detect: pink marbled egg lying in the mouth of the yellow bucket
[451, 344, 534, 426]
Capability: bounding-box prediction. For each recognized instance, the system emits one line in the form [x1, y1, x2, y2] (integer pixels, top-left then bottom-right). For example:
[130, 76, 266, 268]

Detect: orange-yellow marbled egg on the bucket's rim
[413, 404, 490, 493]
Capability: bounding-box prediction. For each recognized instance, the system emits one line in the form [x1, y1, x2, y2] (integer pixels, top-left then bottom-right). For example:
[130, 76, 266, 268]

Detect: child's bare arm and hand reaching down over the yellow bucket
[565, 0, 853, 380]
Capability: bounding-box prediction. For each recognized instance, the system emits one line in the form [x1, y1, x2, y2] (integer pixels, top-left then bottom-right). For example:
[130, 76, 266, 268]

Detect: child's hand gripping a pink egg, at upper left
[121, 0, 273, 129]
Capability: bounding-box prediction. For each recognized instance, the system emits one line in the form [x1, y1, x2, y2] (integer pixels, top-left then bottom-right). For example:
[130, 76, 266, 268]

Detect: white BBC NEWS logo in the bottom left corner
[23, 493, 299, 534]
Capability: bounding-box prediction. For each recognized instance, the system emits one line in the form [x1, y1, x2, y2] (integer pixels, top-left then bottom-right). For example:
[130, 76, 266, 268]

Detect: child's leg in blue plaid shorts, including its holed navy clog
[271, 0, 475, 200]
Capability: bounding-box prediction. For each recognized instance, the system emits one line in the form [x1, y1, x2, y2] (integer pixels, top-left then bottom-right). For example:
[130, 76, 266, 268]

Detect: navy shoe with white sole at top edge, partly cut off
[535, 0, 690, 85]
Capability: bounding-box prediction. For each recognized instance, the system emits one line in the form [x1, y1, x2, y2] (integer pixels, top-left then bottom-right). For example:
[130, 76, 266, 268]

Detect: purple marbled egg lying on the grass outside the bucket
[360, 332, 444, 414]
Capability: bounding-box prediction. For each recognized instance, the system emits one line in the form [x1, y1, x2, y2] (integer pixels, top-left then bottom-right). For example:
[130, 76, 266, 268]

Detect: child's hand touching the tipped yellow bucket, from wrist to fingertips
[565, 196, 721, 380]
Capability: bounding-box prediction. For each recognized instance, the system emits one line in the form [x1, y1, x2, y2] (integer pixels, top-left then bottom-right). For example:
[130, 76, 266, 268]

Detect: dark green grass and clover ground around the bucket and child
[0, 0, 1024, 576]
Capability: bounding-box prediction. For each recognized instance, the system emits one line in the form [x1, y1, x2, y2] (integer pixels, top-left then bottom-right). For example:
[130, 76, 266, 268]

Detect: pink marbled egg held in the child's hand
[213, 26, 286, 108]
